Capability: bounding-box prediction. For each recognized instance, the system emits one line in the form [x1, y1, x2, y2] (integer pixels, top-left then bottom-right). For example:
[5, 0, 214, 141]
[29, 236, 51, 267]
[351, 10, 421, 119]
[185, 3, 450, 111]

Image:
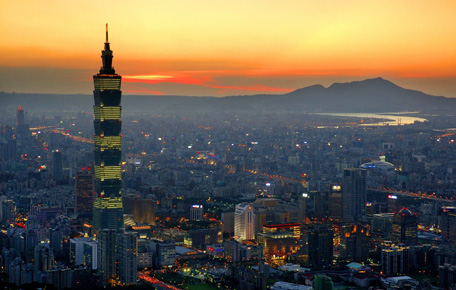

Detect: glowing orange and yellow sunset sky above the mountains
[0, 0, 456, 97]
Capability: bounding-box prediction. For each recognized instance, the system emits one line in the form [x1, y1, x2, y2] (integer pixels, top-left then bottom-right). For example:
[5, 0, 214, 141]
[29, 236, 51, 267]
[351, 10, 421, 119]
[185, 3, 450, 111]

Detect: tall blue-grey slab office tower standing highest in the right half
[342, 168, 367, 222]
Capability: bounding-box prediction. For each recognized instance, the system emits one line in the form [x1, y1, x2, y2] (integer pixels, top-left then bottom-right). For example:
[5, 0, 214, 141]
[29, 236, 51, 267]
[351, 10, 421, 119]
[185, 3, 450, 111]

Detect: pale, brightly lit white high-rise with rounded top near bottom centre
[234, 203, 255, 241]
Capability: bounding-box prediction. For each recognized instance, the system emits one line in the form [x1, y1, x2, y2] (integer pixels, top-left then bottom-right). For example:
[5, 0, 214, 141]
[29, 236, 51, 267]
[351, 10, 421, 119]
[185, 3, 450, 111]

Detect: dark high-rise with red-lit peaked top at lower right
[391, 207, 418, 245]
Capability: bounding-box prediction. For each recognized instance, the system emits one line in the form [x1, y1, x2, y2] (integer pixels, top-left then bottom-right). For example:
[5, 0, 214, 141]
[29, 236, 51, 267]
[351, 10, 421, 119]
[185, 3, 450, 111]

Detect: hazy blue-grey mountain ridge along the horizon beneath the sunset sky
[0, 78, 456, 114]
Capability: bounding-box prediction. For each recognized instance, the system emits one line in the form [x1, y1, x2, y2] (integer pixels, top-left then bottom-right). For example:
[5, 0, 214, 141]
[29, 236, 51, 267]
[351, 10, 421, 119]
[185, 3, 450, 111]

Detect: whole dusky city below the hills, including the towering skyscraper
[4, 31, 456, 290]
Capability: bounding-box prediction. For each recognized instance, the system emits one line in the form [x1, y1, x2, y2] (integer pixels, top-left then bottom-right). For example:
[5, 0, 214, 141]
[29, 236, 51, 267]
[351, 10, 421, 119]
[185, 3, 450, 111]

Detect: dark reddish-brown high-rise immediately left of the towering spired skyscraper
[74, 173, 94, 216]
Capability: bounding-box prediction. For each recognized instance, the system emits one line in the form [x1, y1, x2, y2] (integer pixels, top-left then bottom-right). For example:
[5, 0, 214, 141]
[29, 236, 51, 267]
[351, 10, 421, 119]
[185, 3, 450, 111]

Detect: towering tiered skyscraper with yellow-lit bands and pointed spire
[93, 24, 124, 231]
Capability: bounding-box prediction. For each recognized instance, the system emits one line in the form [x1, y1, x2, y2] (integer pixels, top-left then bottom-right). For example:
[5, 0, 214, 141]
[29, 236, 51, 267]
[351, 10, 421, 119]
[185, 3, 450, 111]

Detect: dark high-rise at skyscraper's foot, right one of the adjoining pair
[117, 232, 138, 285]
